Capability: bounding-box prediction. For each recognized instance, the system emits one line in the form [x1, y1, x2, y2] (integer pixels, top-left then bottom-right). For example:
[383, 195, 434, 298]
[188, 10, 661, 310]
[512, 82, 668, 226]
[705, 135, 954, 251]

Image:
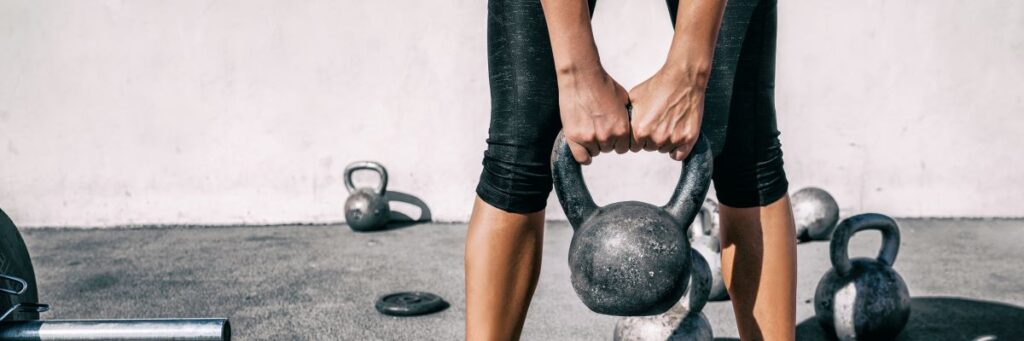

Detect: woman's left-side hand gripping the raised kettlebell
[558, 68, 631, 165]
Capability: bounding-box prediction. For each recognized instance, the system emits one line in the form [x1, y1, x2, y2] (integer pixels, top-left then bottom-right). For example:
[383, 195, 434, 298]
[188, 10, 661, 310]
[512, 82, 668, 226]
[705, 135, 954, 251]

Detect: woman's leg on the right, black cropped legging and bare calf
[670, 0, 797, 340]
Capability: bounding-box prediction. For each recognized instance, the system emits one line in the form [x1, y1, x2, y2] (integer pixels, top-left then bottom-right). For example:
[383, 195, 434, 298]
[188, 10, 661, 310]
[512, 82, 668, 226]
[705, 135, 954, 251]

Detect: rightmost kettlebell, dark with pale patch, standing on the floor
[814, 213, 910, 340]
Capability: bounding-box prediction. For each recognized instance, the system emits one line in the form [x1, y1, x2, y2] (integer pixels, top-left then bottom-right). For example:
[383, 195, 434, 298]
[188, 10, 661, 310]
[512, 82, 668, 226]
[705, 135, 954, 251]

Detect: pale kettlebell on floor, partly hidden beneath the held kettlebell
[612, 246, 715, 341]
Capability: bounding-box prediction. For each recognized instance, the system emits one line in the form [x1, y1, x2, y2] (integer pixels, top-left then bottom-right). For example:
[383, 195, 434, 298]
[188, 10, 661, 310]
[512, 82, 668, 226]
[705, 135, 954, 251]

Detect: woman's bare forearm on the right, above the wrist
[666, 0, 726, 85]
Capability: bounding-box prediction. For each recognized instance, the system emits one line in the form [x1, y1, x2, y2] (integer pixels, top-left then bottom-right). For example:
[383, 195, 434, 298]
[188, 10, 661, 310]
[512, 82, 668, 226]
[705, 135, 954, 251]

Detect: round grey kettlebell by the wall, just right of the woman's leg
[790, 187, 839, 242]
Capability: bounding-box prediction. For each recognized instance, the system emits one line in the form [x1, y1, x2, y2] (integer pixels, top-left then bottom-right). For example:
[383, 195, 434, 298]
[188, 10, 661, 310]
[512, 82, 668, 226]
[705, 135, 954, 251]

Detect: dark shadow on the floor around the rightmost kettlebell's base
[797, 297, 1024, 341]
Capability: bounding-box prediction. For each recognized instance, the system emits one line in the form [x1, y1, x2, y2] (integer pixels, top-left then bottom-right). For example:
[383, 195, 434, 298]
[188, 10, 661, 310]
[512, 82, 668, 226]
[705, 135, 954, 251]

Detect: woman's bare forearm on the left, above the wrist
[541, 0, 601, 76]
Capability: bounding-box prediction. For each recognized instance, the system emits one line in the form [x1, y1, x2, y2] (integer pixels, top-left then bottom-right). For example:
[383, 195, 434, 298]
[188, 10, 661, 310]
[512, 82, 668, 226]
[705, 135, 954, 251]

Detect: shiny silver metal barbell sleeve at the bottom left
[0, 318, 231, 341]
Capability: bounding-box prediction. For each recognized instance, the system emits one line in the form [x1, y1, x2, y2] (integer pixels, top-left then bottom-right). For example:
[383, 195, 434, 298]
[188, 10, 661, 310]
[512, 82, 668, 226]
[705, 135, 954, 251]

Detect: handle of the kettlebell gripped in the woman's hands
[551, 132, 714, 229]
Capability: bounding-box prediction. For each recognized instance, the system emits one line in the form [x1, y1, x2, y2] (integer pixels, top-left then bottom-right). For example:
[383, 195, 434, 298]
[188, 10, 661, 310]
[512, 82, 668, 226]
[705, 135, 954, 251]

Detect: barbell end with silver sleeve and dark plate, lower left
[0, 205, 231, 341]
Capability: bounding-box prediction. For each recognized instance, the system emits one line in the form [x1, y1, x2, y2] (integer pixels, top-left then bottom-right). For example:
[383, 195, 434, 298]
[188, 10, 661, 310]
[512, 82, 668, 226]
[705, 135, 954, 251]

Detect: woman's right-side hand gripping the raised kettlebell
[630, 66, 710, 161]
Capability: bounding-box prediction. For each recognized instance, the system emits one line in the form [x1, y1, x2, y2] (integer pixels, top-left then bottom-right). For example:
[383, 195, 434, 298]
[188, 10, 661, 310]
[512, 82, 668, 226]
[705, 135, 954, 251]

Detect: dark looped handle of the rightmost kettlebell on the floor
[829, 213, 899, 276]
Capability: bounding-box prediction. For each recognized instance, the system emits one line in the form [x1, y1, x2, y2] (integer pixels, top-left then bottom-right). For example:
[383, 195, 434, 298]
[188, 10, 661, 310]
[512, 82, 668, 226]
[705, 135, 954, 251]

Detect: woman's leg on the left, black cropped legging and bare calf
[465, 0, 593, 335]
